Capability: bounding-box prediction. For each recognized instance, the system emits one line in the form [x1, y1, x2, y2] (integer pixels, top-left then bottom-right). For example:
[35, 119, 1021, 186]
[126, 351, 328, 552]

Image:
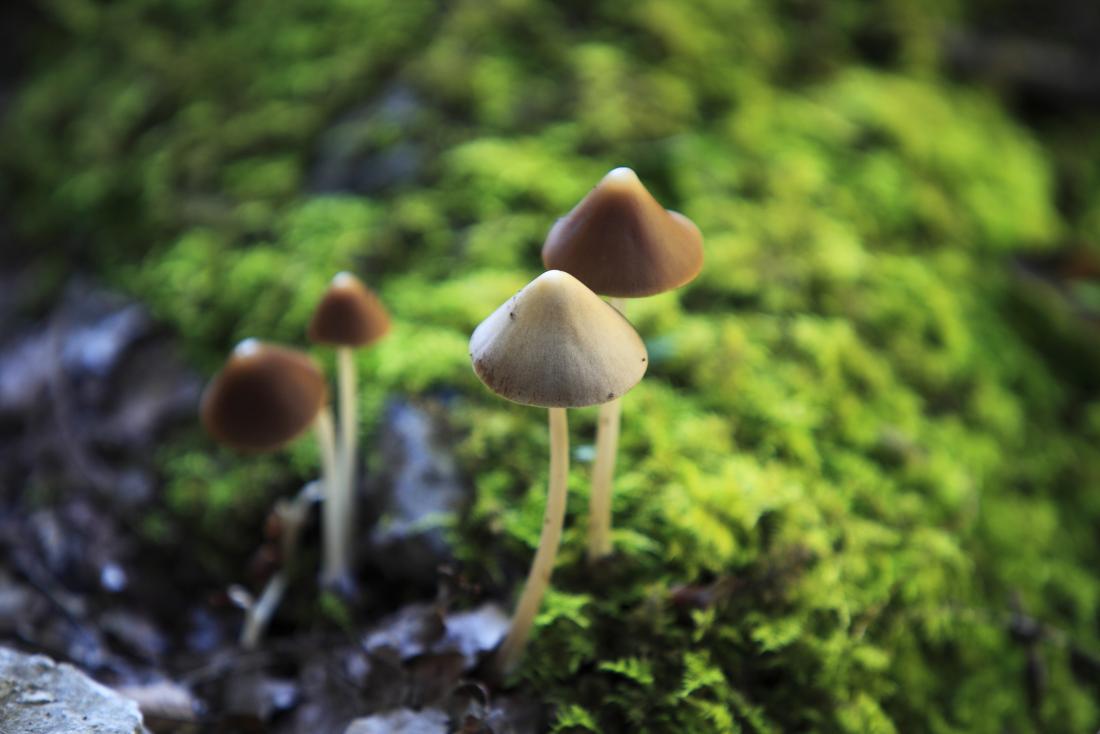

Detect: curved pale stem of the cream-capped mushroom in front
[497, 408, 569, 672]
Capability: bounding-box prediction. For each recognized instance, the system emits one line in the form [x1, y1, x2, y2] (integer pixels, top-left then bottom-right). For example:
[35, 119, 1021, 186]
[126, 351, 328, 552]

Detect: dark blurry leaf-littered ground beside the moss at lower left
[0, 272, 541, 734]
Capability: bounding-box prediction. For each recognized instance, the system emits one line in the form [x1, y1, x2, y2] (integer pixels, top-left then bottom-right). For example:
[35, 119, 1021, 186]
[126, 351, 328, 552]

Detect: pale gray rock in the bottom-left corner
[0, 647, 145, 734]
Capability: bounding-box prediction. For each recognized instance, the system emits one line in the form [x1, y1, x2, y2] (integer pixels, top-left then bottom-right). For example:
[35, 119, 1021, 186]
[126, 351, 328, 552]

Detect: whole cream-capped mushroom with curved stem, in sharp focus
[470, 271, 648, 671]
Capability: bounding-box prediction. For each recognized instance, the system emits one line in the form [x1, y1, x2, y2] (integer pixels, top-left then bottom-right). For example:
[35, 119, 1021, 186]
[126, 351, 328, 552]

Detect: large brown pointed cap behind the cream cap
[542, 168, 703, 298]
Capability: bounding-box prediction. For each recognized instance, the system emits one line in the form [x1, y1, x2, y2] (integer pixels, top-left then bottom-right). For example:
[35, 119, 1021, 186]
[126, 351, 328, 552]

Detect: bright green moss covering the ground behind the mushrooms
[0, 0, 1100, 733]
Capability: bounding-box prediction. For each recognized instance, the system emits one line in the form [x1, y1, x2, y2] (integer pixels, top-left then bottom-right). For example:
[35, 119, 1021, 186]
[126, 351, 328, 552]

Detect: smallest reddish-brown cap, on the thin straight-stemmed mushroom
[309, 273, 389, 347]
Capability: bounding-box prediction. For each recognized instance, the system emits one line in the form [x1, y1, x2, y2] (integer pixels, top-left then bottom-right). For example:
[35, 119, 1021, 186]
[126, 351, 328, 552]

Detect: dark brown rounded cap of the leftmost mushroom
[200, 339, 326, 451]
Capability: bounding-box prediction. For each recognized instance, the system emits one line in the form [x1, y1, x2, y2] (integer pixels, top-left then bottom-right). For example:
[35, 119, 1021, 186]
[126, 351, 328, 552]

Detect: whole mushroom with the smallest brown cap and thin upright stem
[309, 273, 389, 582]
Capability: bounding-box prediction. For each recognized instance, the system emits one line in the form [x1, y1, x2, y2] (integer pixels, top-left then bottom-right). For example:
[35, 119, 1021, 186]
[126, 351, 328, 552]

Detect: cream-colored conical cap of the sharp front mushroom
[470, 271, 649, 408]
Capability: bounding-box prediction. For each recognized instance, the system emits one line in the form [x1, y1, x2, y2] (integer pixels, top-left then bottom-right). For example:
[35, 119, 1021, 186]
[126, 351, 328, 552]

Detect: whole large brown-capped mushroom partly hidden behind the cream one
[542, 167, 703, 562]
